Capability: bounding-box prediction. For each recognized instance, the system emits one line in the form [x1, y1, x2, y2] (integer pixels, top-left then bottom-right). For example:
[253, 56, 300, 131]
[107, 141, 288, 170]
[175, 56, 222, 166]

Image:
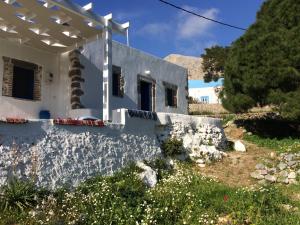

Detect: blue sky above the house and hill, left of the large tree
[74, 0, 264, 57]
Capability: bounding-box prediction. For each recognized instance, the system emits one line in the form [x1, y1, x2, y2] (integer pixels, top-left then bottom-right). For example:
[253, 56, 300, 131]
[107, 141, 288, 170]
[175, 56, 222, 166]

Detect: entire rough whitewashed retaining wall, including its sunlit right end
[0, 112, 226, 189]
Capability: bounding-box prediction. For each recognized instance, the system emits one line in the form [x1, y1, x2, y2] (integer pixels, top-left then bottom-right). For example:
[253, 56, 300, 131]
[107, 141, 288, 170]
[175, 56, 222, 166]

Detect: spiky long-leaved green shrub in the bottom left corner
[0, 178, 38, 212]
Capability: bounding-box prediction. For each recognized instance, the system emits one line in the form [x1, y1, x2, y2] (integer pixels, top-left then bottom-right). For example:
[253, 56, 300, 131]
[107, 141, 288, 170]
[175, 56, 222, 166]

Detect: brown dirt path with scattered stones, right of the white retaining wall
[198, 118, 300, 186]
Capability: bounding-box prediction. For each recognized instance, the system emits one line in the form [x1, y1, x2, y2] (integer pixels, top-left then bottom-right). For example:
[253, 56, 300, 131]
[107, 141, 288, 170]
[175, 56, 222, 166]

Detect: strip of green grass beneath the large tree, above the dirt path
[244, 134, 300, 153]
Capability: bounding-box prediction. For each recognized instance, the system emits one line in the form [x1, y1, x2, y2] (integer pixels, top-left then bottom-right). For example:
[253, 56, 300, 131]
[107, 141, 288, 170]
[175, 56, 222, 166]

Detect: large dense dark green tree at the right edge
[222, 0, 300, 120]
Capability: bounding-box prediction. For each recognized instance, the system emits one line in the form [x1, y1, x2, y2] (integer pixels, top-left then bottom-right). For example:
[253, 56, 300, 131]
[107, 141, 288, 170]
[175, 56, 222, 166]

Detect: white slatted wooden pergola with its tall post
[0, 0, 129, 120]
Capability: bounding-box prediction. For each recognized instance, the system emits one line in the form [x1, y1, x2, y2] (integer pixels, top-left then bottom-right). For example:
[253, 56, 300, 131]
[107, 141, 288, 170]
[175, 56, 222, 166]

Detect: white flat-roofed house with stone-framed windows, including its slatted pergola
[0, 0, 188, 120]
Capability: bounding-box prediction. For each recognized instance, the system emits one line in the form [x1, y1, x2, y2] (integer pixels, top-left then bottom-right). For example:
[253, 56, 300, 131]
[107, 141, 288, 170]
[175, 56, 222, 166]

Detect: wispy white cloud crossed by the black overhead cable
[177, 6, 219, 39]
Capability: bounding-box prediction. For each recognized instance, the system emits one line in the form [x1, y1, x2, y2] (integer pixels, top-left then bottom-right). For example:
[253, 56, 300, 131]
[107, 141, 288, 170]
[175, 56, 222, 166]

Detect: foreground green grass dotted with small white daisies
[0, 163, 300, 225]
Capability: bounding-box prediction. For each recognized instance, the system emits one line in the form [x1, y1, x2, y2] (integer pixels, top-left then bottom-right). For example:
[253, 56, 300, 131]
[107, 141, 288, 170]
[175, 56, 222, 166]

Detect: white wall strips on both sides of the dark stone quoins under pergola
[57, 39, 103, 118]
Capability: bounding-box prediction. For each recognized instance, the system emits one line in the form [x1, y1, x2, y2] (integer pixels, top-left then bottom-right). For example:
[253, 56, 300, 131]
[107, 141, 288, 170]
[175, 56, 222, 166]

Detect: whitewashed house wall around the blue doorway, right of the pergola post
[111, 42, 187, 114]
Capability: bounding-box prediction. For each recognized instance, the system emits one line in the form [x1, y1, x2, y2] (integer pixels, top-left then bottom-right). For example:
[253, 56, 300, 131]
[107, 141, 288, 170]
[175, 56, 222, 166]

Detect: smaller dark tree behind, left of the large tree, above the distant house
[201, 45, 229, 82]
